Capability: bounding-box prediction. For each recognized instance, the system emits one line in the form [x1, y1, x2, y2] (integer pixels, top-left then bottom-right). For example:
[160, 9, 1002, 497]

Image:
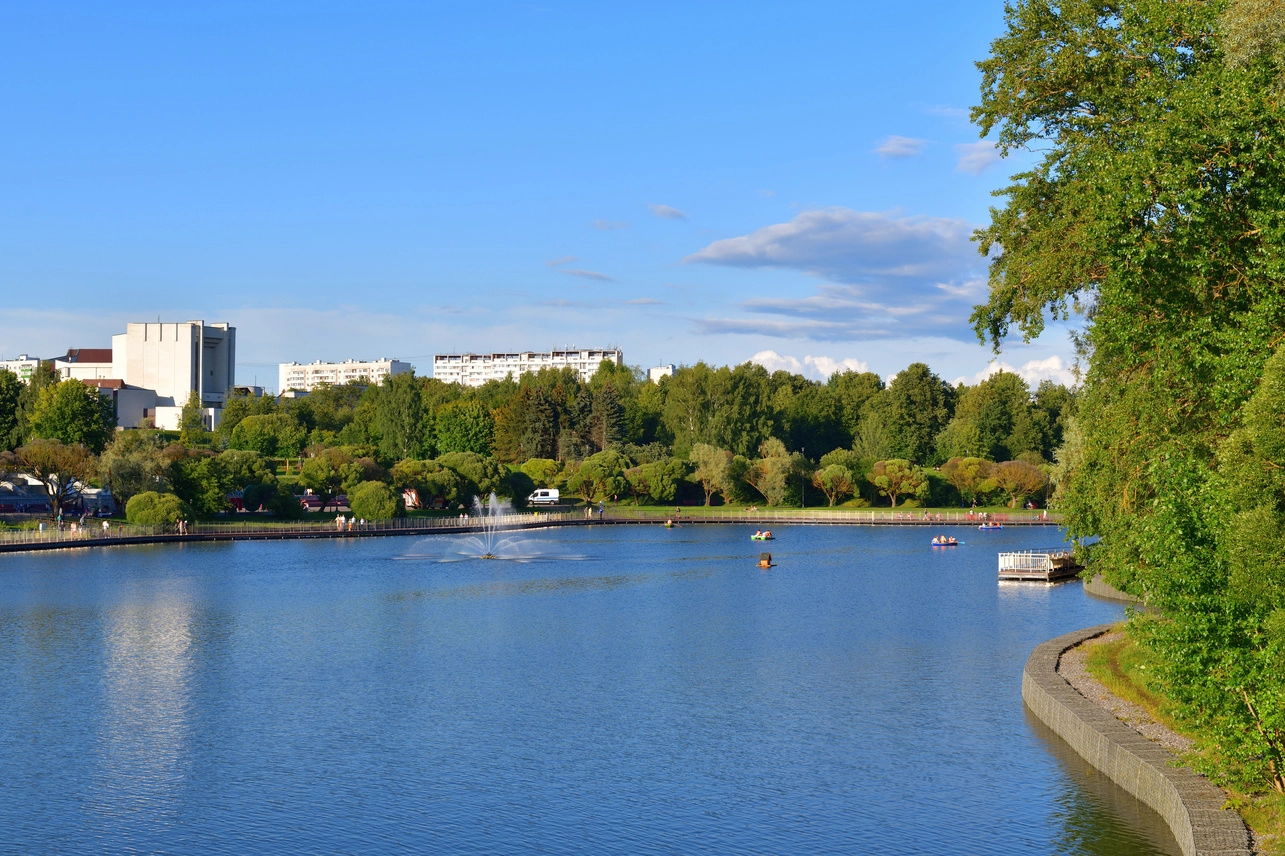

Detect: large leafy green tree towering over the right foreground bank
[973, 0, 1285, 789]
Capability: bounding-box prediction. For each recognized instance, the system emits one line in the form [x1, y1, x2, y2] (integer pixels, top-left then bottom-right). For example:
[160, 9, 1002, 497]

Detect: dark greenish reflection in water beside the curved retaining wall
[1023, 708, 1182, 856]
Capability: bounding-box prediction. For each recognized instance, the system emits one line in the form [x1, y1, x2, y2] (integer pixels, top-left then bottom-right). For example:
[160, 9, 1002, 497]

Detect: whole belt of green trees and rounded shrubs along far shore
[0, 349, 1074, 521]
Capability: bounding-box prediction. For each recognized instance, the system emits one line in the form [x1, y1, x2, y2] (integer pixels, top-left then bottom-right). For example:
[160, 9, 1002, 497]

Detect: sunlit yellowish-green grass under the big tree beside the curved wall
[1085, 626, 1285, 856]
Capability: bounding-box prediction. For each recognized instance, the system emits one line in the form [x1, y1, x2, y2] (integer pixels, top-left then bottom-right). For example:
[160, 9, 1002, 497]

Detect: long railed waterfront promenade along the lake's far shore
[0, 506, 1061, 553]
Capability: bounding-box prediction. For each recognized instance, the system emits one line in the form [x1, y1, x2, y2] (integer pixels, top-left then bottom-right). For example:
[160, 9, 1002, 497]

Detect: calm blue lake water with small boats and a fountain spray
[0, 526, 1176, 855]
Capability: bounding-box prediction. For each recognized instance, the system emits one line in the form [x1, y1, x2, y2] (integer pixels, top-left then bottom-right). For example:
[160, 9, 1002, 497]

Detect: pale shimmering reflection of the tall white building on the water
[91, 585, 194, 816]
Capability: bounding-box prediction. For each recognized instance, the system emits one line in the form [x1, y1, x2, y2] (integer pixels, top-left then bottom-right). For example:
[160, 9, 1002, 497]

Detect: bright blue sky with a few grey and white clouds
[0, 0, 1073, 388]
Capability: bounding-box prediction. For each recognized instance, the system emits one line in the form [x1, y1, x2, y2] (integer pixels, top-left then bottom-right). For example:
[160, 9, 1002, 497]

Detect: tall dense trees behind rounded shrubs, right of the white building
[215, 361, 1074, 467]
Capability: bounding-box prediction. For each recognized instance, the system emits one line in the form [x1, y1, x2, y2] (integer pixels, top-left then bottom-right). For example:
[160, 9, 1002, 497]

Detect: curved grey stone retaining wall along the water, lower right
[1022, 625, 1252, 856]
